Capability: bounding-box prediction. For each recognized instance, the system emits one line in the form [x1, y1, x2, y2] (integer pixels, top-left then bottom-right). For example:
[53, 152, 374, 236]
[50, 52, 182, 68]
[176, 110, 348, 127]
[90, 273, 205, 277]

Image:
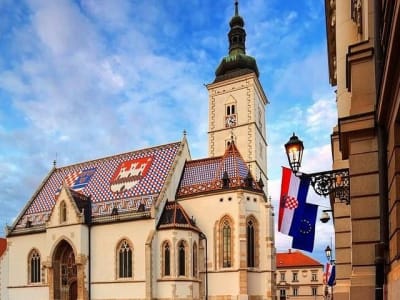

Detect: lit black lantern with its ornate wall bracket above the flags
[285, 133, 350, 204]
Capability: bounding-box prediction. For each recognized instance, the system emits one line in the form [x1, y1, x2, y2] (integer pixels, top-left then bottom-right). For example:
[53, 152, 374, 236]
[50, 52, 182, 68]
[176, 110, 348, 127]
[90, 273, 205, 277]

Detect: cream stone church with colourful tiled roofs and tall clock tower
[5, 2, 276, 300]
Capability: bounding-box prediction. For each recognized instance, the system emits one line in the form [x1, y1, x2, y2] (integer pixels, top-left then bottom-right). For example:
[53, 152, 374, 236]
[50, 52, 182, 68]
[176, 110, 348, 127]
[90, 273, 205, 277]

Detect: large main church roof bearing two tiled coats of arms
[12, 142, 181, 228]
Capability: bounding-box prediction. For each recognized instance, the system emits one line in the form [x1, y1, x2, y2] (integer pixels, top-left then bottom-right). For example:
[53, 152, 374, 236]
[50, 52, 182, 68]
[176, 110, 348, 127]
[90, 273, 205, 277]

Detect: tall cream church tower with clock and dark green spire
[207, 1, 268, 193]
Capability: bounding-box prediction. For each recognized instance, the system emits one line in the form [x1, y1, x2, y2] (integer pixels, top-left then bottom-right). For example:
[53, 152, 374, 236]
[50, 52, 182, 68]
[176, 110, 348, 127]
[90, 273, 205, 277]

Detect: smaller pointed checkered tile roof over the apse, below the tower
[177, 142, 262, 197]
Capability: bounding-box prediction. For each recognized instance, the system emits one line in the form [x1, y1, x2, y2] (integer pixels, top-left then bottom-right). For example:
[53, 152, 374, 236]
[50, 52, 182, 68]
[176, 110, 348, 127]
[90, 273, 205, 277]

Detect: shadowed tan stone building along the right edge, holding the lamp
[325, 0, 400, 300]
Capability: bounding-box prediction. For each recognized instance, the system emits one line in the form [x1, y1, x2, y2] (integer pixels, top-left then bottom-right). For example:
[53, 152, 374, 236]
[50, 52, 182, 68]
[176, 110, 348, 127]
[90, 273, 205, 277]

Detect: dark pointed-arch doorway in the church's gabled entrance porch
[53, 240, 78, 300]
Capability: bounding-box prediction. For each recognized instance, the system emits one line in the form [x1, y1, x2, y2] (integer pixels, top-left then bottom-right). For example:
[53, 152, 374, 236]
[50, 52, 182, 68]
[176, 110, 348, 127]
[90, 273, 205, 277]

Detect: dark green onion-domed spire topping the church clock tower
[214, 1, 259, 82]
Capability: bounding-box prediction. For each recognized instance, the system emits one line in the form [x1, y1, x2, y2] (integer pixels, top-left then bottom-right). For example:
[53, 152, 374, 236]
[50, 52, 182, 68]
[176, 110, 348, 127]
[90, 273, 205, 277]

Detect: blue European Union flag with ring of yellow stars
[290, 203, 318, 252]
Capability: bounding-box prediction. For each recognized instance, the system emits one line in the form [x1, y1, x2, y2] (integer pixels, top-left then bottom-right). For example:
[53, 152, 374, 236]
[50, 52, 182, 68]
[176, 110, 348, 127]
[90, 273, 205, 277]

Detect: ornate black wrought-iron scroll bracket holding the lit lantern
[296, 168, 350, 204]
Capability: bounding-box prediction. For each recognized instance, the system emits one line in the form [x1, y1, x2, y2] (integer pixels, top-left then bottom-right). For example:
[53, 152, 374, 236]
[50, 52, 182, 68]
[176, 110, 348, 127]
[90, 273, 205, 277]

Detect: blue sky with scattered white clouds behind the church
[0, 0, 337, 261]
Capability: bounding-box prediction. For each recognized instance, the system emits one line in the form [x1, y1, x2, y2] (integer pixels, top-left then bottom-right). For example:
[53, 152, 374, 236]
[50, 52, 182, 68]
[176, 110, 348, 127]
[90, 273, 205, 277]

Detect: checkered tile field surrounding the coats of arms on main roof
[21, 143, 180, 226]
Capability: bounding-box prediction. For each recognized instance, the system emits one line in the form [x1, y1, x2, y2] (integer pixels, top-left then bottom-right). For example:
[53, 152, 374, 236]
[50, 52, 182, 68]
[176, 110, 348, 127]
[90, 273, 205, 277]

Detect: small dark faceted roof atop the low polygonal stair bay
[157, 201, 200, 232]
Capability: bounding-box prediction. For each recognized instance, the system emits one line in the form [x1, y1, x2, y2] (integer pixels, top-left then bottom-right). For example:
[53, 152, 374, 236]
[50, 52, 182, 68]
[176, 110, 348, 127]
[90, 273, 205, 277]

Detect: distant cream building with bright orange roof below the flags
[275, 249, 324, 300]
